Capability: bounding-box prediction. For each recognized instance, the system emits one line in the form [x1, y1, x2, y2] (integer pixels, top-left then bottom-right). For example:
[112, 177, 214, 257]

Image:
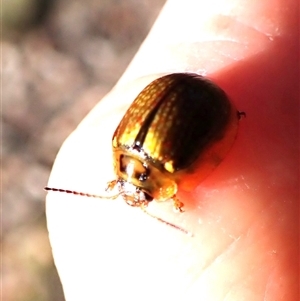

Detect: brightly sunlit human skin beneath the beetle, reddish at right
[46, 0, 299, 301]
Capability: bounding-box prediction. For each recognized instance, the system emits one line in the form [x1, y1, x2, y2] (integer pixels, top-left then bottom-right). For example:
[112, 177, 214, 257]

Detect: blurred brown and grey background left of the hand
[1, 0, 166, 301]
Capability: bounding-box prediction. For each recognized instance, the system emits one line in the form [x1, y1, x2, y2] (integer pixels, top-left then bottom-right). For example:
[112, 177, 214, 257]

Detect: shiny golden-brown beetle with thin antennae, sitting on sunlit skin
[45, 73, 245, 234]
